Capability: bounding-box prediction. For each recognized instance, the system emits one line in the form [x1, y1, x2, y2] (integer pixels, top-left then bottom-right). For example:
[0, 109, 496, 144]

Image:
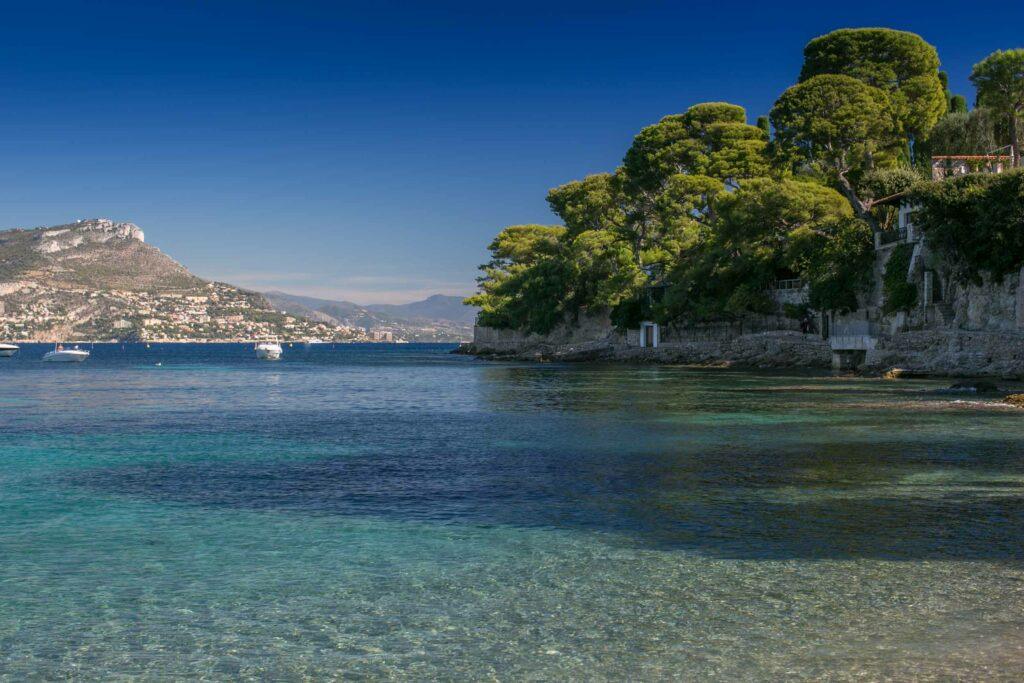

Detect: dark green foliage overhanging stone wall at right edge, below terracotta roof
[914, 170, 1024, 284]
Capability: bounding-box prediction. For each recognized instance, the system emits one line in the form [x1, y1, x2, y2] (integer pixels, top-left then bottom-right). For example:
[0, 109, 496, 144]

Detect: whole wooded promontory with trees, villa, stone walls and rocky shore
[463, 29, 1024, 377]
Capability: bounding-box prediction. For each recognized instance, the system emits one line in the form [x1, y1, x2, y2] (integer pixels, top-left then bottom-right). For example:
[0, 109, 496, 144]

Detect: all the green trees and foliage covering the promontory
[467, 29, 1011, 333]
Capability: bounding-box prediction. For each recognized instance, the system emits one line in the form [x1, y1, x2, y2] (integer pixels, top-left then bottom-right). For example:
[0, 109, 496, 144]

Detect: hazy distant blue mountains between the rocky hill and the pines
[263, 292, 476, 341]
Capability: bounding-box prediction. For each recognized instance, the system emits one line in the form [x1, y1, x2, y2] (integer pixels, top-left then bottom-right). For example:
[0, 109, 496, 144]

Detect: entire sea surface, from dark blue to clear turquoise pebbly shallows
[0, 345, 1024, 680]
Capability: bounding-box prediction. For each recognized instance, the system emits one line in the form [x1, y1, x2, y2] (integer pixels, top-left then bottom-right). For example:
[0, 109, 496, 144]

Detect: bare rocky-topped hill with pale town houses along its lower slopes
[0, 218, 468, 342]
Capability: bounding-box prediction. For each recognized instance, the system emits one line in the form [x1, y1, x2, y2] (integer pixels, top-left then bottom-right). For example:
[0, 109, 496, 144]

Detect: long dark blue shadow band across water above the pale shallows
[66, 418, 1024, 562]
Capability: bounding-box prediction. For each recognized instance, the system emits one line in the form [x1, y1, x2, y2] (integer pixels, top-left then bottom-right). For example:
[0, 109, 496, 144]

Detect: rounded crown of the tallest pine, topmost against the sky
[800, 29, 947, 137]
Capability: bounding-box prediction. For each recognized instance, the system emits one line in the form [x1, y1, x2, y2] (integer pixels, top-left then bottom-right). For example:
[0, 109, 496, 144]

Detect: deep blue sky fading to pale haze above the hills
[0, 0, 1024, 303]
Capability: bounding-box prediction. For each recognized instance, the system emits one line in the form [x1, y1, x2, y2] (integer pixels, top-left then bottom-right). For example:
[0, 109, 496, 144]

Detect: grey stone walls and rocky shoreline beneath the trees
[464, 264, 1024, 378]
